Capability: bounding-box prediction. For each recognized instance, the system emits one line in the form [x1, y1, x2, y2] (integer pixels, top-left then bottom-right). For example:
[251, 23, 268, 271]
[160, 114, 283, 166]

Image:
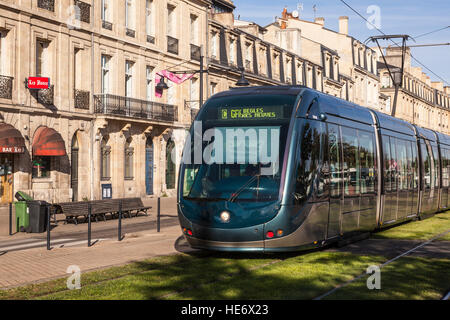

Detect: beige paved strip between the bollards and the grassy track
[0, 226, 189, 288]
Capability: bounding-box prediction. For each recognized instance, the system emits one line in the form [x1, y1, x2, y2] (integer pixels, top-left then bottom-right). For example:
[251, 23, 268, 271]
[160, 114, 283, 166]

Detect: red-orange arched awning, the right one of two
[33, 127, 66, 156]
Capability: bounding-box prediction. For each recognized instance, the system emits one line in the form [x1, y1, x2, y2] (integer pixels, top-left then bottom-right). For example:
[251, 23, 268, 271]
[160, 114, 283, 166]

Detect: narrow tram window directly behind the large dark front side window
[328, 124, 342, 198]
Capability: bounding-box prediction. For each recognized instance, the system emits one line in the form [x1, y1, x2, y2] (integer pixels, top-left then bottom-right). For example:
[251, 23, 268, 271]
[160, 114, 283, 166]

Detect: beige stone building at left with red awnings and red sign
[0, 0, 210, 203]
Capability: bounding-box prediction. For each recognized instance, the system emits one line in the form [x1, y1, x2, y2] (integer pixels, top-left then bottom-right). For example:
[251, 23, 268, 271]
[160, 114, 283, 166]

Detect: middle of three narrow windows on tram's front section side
[342, 127, 361, 196]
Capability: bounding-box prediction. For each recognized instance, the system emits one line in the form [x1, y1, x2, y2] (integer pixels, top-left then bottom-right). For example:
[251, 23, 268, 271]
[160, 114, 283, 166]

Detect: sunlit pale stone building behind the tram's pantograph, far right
[379, 47, 450, 134]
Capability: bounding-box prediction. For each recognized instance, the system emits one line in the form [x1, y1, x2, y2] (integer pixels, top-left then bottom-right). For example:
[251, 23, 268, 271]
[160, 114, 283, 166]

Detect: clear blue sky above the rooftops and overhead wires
[233, 0, 450, 85]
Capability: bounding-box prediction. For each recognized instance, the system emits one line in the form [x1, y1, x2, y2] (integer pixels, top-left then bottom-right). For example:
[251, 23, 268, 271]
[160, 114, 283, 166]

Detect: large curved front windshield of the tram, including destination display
[181, 95, 296, 202]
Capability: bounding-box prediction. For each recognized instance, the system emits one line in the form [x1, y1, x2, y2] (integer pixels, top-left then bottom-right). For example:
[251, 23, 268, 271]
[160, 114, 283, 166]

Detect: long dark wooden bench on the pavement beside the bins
[54, 198, 151, 224]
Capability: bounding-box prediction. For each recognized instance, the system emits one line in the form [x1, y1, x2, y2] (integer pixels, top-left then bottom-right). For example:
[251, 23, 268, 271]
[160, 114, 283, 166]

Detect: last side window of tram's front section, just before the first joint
[358, 130, 376, 194]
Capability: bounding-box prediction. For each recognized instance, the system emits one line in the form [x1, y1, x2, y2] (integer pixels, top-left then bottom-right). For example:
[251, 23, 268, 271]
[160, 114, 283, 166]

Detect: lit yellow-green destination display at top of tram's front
[218, 106, 284, 120]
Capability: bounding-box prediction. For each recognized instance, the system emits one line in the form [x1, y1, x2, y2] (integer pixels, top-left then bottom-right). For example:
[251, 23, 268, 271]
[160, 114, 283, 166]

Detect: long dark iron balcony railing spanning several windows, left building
[94, 94, 178, 122]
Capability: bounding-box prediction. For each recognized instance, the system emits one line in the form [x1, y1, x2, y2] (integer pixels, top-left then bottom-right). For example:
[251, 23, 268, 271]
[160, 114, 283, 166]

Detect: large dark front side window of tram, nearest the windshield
[295, 121, 325, 203]
